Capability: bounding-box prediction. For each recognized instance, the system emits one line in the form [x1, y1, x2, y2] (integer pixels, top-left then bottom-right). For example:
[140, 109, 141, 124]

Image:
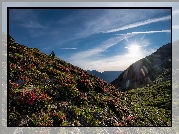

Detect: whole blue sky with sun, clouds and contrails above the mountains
[9, 9, 171, 71]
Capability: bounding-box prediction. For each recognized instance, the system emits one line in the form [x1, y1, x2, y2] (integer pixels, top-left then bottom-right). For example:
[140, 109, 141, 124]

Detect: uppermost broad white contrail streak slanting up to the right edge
[104, 15, 171, 33]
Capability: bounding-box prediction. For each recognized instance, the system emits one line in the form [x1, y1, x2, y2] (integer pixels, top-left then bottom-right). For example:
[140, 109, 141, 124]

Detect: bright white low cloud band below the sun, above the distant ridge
[70, 49, 155, 72]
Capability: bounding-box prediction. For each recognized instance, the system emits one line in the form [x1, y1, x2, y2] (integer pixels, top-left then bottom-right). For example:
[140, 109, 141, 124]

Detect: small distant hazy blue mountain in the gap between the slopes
[87, 70, 122, 83]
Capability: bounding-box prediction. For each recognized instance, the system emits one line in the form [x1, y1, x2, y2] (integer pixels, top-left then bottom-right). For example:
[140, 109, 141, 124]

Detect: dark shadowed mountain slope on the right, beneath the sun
[111, 43, 172, 91]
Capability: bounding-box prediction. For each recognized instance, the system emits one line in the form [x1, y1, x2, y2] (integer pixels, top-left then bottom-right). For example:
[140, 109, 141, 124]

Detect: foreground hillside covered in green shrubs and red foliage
[7, 36, 172, 127]
